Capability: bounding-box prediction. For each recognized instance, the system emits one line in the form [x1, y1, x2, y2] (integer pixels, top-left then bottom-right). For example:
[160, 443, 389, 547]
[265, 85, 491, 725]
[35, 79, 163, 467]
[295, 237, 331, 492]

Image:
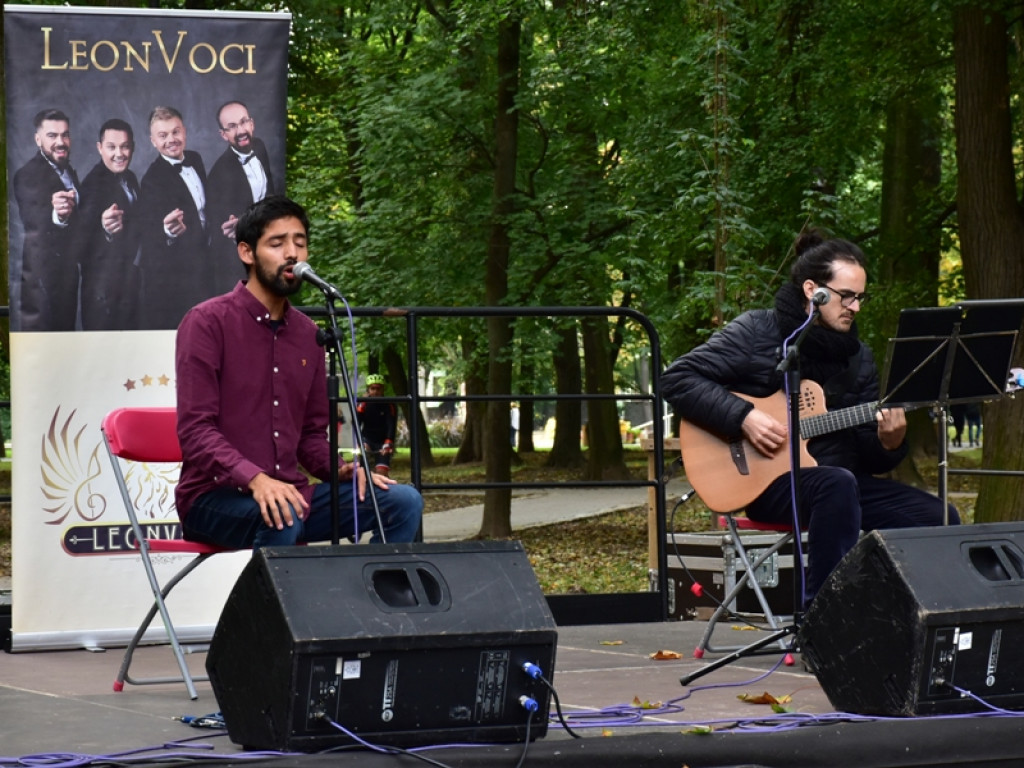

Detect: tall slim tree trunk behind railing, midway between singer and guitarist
[479, 17, 520, 539]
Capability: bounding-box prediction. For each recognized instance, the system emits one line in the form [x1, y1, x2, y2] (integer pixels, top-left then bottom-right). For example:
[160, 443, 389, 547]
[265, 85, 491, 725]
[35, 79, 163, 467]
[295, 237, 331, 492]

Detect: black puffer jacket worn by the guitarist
[662, 309, 907, 474]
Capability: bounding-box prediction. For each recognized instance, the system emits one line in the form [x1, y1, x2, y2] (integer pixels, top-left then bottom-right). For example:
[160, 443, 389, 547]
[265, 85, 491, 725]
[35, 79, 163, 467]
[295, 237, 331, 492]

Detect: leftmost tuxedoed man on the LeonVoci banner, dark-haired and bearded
[14, 109, 81, 331]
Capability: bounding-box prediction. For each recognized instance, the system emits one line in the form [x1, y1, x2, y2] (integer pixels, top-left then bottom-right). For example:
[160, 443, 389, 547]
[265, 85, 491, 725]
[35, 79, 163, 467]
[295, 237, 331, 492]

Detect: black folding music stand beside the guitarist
[880, 299, 1024, 523]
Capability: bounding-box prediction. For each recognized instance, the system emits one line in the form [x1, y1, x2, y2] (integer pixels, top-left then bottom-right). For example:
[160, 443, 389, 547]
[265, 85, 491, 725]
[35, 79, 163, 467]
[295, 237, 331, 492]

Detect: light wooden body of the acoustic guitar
[679, 381, 831, 512]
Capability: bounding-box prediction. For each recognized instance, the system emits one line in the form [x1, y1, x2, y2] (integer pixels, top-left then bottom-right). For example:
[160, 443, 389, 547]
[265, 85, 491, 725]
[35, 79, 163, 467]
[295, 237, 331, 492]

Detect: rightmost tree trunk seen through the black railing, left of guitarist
[583, 317, 629, 480]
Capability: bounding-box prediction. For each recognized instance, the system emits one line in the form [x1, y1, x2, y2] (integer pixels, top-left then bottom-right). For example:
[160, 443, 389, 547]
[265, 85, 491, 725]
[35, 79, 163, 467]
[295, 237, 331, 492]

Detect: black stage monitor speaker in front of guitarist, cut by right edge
[799, 522, 1024, 715]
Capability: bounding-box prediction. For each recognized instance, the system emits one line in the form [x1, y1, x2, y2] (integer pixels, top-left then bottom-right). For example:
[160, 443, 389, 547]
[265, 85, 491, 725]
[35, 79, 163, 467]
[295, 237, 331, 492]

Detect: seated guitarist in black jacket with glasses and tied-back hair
[662, 231, 959, 603]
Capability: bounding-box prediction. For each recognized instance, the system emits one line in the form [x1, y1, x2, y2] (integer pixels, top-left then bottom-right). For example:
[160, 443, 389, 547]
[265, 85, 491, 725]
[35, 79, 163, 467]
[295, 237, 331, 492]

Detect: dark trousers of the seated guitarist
[746, 467, 959, 604]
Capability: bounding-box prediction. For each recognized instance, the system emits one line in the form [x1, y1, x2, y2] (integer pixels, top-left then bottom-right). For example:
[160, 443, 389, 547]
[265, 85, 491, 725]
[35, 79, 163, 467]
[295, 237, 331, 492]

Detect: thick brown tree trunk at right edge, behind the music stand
[953, 4, 1024, 522]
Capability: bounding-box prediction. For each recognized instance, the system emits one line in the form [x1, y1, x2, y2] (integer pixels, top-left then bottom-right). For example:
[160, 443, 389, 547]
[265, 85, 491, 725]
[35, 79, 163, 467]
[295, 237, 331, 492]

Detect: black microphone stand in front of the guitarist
[679, 301, 818, 685]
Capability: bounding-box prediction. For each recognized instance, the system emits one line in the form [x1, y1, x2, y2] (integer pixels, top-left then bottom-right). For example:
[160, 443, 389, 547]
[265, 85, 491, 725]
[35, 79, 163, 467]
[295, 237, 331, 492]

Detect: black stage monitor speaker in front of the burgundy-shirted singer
[206, 542, 557, 751]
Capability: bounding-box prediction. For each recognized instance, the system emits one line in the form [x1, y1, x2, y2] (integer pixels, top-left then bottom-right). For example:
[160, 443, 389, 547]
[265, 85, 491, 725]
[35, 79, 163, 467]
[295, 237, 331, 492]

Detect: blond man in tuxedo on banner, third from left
[140, 106, 213, 330]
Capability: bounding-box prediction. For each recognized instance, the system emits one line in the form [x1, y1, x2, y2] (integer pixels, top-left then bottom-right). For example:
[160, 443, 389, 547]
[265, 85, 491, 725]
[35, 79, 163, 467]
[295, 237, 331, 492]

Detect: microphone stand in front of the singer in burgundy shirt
[316, 286, 385, 546]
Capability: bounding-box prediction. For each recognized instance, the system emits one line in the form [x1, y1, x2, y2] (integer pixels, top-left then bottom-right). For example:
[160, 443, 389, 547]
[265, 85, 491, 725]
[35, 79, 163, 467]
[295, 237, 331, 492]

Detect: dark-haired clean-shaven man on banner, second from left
[79, 118, 141, 331]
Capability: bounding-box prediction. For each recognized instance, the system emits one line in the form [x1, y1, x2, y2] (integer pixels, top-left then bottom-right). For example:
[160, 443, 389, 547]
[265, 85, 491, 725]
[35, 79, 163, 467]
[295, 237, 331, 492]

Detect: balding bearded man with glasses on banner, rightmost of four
[207, 101, 283, 293]
